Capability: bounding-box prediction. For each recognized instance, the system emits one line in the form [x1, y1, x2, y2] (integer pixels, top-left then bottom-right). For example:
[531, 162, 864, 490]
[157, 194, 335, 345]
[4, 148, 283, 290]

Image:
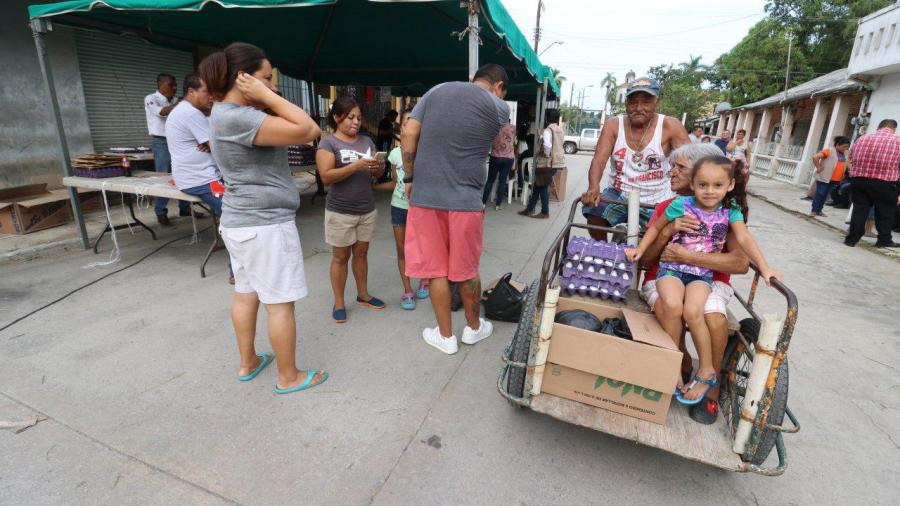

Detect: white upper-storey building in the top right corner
[849, 2, 900, 131]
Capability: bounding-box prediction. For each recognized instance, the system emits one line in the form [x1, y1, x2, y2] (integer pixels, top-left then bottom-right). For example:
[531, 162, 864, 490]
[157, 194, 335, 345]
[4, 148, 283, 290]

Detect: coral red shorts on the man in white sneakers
[404, 205, 484, 281]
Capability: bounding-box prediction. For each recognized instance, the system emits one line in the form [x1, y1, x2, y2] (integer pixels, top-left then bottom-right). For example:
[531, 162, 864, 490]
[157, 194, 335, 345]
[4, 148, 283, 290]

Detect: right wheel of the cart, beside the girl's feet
[719, 318, 789, 465]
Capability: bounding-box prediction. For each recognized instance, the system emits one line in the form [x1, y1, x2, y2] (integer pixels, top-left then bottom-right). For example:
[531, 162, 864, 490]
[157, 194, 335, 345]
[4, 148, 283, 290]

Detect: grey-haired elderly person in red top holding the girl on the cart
[641, 143, 750, 424]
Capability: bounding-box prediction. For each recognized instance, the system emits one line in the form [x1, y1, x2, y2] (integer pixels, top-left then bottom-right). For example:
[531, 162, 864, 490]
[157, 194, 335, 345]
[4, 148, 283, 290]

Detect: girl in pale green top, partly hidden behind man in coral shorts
[376, 107, 428, 310]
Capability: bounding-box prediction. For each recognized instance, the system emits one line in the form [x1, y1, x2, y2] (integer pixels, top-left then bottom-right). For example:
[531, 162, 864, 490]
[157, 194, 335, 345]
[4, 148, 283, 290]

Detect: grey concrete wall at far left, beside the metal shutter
[0, 0, 93, 188]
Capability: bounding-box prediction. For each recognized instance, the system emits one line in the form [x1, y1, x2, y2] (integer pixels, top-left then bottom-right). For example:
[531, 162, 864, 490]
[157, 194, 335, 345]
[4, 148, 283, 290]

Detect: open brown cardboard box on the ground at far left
[0, 183, 72, 235]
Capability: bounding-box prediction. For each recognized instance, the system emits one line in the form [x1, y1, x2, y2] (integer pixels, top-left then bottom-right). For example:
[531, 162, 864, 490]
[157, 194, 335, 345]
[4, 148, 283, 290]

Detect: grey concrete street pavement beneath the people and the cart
[0, 155, 900, 505]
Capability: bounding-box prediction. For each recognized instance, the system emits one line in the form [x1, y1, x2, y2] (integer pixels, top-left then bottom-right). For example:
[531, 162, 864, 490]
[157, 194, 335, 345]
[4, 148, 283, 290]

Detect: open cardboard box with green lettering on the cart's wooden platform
[541, 297, 681, 424]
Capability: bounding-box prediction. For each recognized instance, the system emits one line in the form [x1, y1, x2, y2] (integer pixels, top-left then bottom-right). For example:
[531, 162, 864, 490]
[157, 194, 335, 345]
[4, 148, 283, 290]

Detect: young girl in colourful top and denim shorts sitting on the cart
[626, 156, 781, 405]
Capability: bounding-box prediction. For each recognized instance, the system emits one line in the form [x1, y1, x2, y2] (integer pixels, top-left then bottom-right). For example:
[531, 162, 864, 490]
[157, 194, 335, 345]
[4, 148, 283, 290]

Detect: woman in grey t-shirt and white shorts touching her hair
[199, 42, 328, 394]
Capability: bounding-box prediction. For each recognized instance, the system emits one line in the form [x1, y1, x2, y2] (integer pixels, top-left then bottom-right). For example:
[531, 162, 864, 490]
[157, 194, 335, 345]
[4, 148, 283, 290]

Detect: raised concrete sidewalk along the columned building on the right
[747, 174, 900, 259]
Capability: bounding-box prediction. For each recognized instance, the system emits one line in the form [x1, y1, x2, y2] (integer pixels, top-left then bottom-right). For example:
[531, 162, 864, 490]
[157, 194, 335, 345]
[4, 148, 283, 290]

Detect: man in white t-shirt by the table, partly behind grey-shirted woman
[165, 74, 231, 280]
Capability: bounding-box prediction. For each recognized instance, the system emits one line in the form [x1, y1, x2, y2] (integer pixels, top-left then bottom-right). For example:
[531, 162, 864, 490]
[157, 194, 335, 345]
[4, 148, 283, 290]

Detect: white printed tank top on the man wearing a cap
[611, 114, 675, 204]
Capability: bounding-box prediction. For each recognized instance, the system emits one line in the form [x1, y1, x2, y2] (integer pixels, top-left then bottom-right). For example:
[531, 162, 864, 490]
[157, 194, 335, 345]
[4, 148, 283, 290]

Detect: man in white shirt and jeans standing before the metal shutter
[144, 74, 191, 227]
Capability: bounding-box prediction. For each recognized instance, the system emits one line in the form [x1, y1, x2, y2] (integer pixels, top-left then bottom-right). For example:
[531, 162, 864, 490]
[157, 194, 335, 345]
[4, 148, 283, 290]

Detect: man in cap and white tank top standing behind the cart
[581, 77, 691, 239]
